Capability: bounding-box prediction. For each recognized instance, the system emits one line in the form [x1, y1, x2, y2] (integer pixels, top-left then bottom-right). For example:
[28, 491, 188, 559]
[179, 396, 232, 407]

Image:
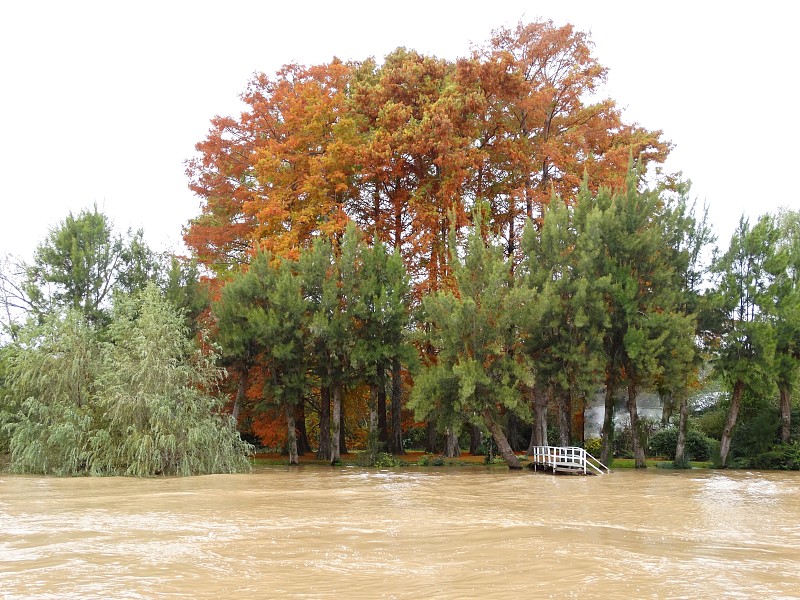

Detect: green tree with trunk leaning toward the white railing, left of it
[410, 211, 531, 469]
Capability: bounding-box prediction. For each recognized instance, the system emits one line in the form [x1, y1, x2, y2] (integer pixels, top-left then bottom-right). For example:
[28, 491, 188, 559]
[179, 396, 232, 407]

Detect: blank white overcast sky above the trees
[0, 0, 800, 260]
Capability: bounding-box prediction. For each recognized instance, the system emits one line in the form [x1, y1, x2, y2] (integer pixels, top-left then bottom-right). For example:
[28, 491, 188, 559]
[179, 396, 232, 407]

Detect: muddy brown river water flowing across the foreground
[0, 467, 800, 599]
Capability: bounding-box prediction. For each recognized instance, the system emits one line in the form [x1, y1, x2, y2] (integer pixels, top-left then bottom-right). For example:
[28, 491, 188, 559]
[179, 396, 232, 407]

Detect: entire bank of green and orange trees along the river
[0, 22, 800, 474]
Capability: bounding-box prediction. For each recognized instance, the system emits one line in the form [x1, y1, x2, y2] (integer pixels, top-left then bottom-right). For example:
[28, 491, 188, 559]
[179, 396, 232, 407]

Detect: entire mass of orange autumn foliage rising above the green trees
[184, 21, 670, 454]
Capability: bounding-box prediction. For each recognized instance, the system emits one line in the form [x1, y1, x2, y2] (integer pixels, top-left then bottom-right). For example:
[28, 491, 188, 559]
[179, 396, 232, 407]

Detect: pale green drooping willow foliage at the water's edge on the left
[3, 285, 250, 477]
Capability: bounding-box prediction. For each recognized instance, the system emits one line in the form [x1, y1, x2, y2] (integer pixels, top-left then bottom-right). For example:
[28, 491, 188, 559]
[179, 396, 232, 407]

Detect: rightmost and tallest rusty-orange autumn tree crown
[457, 21, 669, 264]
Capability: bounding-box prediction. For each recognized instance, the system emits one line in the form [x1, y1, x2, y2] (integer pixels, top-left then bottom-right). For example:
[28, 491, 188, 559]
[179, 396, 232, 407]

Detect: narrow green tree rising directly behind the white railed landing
[516, 186, 608, 446]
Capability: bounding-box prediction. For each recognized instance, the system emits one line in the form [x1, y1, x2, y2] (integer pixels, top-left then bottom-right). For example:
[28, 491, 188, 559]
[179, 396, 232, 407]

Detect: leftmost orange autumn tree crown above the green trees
[184, 60, 352, 271]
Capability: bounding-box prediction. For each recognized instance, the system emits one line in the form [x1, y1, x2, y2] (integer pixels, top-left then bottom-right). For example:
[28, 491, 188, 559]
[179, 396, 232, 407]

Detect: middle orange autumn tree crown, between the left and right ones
[348, 48, 472, 292]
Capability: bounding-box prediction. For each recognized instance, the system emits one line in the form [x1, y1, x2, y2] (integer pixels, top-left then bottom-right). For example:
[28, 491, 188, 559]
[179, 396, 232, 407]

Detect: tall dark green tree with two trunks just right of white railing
[582, 166, 695, 467]
